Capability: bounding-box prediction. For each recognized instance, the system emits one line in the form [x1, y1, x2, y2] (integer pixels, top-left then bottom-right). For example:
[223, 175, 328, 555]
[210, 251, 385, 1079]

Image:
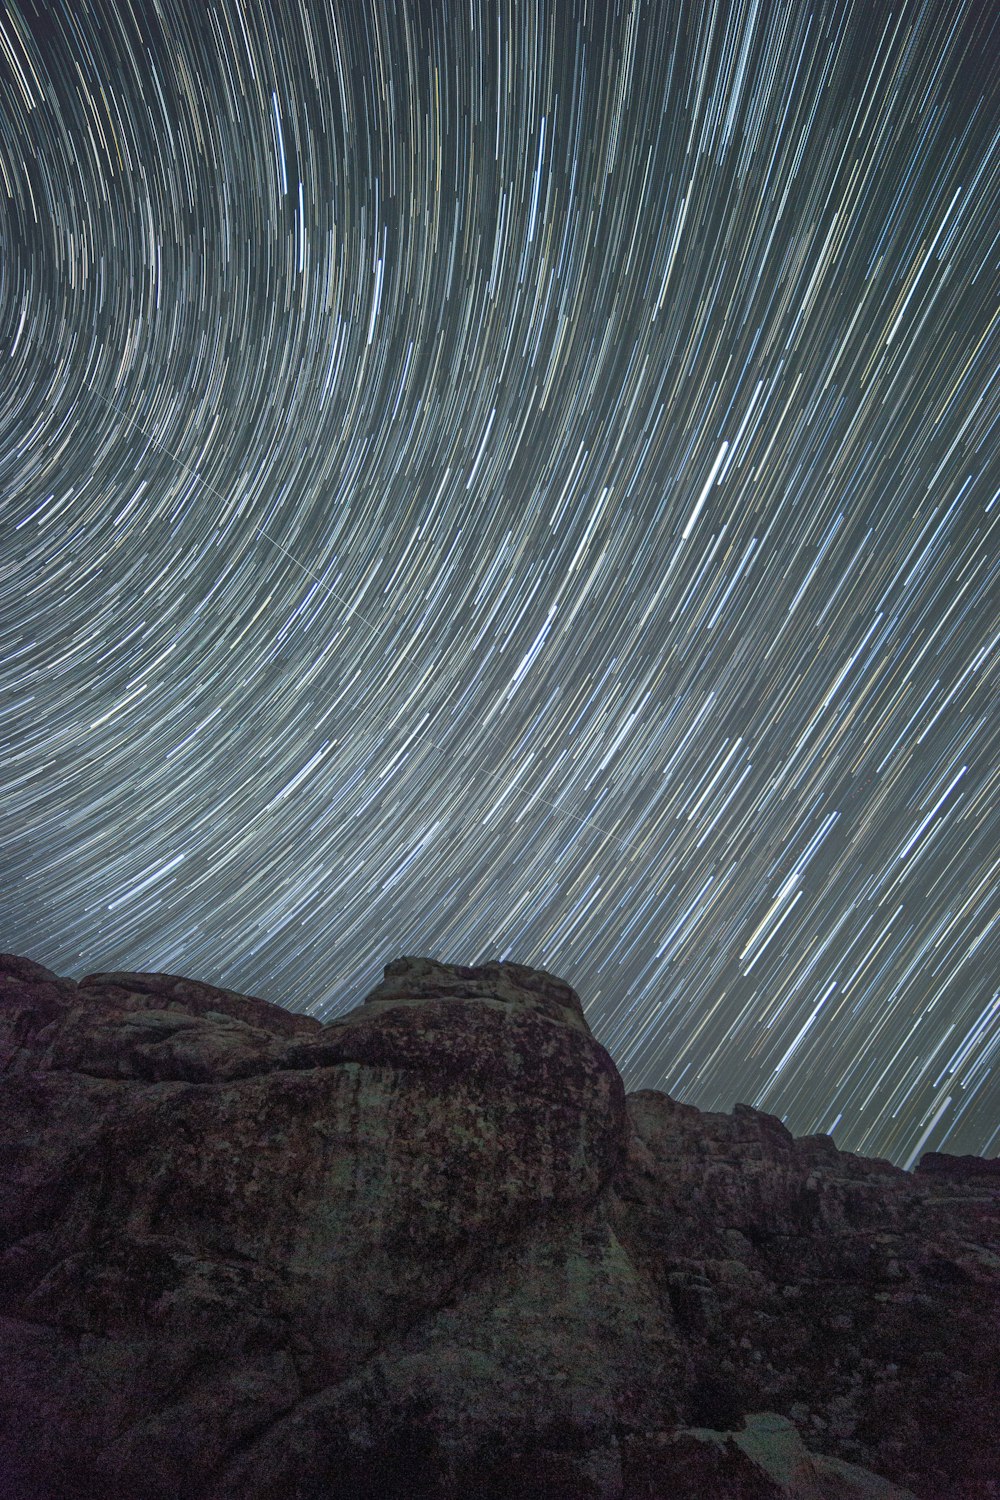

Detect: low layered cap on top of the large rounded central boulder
[364, 957, 591, 1035]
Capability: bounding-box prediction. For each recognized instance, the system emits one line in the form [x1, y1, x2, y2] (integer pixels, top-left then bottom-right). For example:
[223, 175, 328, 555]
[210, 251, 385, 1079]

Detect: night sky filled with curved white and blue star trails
[0, 0, 1000, 1166]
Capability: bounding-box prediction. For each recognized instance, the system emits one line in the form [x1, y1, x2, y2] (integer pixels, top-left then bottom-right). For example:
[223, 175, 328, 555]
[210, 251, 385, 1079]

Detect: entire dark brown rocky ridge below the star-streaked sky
[0, 956, 1000, 1500]
